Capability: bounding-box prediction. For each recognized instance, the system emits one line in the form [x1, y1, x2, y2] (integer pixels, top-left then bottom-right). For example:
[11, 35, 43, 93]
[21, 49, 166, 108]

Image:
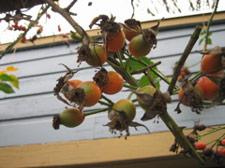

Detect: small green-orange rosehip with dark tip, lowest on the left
[52, 108, 85, 129]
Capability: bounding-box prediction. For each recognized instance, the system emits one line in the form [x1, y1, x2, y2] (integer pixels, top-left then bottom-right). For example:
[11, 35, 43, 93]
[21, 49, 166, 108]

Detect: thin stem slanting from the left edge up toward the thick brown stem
[0, 6, 49, 59]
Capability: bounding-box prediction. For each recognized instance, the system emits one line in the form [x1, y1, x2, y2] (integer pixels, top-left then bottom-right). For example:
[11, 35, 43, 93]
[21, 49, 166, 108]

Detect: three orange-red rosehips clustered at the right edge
[178, 49, 225, 112]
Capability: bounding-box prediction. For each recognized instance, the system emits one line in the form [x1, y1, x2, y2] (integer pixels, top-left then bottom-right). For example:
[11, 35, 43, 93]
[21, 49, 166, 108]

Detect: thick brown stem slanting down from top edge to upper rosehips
[45, 0, 90, 46]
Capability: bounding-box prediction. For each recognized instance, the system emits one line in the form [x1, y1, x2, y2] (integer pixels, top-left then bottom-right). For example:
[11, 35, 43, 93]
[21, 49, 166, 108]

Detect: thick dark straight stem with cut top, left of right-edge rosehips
[168, 26, 202, 95]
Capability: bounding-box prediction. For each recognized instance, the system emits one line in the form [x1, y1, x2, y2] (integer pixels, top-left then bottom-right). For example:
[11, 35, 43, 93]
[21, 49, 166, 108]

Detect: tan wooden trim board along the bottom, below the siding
[0, 125, 225, 168]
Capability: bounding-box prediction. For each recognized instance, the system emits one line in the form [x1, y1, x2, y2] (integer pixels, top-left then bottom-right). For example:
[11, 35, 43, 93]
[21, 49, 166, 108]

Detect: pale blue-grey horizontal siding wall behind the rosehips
[0, 24, 225, 146]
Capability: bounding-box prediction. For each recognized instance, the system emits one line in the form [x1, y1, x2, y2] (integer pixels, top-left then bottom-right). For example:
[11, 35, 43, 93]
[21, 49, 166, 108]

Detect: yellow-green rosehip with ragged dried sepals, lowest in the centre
[105, 99, 150, 138]
